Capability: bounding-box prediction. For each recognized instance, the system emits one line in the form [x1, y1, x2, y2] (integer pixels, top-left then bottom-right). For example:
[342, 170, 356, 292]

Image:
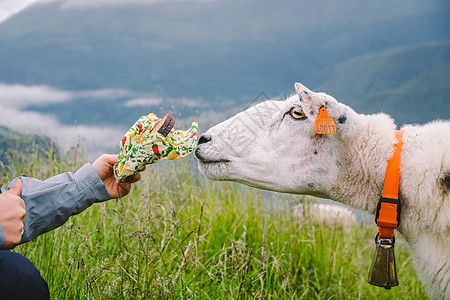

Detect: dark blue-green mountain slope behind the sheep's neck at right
[318, 42, 450, 125]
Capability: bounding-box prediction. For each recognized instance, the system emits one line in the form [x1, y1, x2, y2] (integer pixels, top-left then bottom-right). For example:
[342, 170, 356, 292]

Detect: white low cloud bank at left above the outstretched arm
[0, 83, 134, 160]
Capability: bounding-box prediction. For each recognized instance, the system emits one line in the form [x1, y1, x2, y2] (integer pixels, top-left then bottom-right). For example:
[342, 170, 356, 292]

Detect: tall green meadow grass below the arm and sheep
[2, 149, 426, 299]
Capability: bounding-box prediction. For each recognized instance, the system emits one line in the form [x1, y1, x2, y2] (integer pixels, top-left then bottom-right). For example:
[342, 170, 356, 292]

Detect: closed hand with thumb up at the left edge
[0, 179, 27, 249]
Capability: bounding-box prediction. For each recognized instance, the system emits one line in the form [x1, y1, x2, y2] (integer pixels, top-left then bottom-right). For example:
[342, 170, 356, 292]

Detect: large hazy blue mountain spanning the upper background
[0, 0, 450, 103]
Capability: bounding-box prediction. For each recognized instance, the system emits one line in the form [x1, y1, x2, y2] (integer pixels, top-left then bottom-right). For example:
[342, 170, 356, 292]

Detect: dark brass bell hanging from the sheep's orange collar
[369, 234, 398, 290]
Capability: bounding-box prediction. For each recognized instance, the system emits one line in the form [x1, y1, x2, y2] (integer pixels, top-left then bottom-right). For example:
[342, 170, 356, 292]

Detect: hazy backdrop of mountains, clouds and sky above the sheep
[0, 0, 450, 159]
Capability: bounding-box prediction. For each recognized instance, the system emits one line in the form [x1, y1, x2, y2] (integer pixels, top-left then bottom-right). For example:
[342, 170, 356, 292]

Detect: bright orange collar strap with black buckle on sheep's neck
[375, 130, 403, 240]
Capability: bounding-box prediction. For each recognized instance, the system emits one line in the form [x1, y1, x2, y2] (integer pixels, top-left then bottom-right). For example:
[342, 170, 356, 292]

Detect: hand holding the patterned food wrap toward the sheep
[92, 154, 141, 199]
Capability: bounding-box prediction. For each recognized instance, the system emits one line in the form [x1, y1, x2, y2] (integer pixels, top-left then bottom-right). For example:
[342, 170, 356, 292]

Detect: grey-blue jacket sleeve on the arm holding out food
[0, 163, 111, 248]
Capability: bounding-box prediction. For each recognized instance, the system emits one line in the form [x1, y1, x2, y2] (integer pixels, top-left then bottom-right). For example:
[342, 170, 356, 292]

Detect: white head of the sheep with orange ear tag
[195, 83, 358, 196]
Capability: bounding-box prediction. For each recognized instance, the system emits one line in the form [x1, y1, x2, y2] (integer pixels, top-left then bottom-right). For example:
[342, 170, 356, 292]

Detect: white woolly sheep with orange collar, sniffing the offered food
[195, 83, 450, 299]
